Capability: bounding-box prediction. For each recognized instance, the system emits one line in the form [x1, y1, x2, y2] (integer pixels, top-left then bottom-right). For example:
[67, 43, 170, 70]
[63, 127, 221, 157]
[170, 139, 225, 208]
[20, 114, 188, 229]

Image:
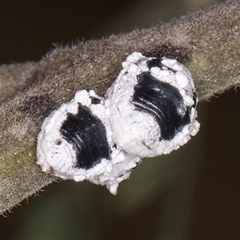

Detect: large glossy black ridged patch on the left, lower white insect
[60, 104, 111, 169]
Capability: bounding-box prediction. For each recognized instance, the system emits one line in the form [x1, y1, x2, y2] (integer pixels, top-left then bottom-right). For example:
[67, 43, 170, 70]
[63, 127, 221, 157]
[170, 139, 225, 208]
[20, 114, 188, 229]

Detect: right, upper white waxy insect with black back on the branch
[106, 53, 199, 157]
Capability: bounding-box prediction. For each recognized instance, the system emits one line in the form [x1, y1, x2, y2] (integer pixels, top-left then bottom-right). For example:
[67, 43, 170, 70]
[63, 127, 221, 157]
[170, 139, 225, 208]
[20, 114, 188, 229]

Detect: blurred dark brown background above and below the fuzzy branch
[0, 0, 240, 239]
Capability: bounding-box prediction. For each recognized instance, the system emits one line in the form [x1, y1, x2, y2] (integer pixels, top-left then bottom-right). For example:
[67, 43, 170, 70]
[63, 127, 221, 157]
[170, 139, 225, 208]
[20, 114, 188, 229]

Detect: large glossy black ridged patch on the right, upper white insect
[132, 72, 190, 140]
